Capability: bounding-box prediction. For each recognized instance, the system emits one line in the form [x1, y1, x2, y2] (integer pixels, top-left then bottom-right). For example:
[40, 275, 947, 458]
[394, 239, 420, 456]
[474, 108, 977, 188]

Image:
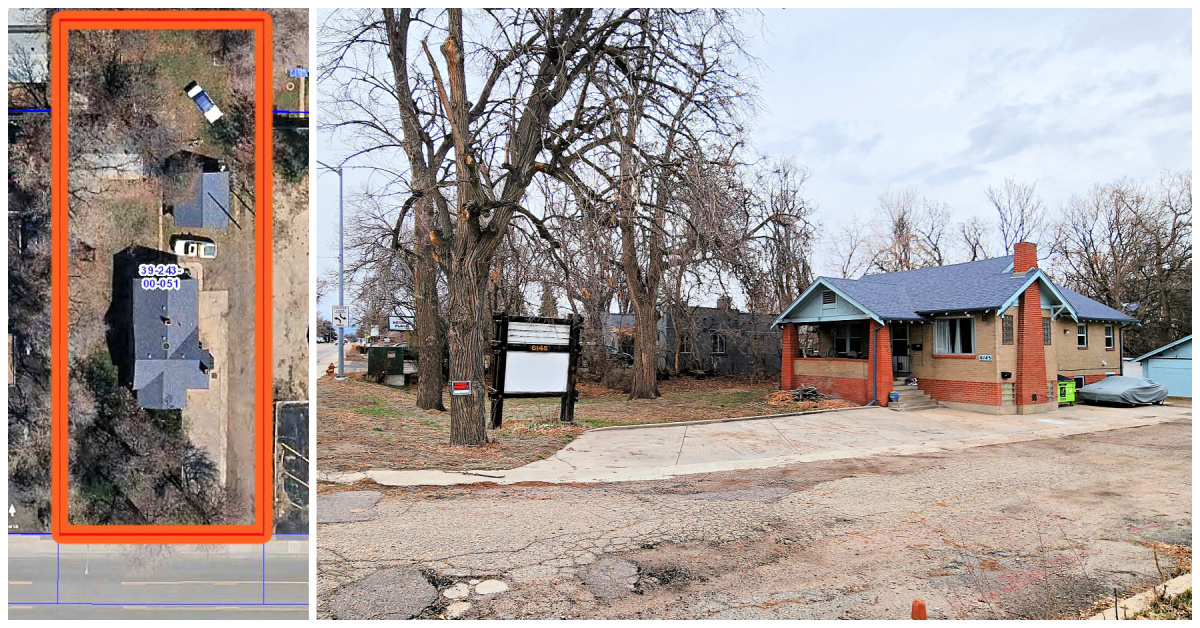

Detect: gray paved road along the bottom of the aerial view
[8, 536, 308, 618]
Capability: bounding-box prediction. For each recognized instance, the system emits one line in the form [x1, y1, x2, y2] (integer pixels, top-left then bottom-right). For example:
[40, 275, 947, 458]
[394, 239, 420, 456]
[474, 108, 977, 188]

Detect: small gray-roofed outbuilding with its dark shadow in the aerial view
[162, 150, 232, 231]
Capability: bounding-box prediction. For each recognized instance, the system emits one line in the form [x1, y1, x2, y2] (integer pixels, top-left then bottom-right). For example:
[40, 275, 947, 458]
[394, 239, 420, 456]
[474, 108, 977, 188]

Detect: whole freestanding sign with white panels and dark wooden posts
[488, 313, 583, 430]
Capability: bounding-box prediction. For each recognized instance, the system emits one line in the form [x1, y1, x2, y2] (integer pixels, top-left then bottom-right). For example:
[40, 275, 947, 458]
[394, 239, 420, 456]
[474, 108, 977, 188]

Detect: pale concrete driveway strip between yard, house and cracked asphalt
[319, 405, 1192, 486]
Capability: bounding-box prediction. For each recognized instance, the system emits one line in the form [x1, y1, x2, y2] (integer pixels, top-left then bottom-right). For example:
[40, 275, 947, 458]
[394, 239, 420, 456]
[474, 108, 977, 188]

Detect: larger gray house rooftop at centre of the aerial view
[133, 279, 212, 409]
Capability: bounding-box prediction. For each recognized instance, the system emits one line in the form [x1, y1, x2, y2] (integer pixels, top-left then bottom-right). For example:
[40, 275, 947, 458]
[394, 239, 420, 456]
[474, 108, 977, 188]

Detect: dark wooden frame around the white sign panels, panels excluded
[488, 312, 583, 430]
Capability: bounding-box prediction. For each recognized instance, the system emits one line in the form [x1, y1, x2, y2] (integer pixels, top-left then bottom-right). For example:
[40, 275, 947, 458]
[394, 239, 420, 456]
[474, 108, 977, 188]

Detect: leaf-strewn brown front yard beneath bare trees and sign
[317, 373, 852, 471]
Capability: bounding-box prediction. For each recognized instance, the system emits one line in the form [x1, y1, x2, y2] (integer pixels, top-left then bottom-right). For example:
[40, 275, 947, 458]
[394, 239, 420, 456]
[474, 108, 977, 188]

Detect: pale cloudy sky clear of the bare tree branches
[314, 10, 1192, 307]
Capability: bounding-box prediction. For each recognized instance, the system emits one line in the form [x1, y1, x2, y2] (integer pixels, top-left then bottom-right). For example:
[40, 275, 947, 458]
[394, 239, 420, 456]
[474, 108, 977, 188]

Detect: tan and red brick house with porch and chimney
[774, 243, 1138, 414]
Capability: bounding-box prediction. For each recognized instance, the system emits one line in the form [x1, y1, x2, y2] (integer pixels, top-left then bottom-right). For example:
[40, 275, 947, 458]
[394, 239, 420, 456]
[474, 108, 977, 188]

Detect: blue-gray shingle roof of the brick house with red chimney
[796, 256, 1136, 323]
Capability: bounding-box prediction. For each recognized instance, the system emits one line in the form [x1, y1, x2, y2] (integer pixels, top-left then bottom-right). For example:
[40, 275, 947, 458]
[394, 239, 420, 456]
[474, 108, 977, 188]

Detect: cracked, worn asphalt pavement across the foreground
[317, 417, 1192, 618]
